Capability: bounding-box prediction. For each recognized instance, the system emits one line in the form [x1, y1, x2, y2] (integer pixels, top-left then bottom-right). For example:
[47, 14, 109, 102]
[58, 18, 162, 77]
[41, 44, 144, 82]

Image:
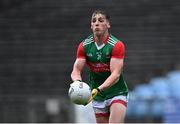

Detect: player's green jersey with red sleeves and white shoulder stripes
[77, 34, 128, 101]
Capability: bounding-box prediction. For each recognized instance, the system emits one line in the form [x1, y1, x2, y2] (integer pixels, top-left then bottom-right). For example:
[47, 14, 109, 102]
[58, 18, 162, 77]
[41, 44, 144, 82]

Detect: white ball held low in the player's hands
[68, 81, 91, 105]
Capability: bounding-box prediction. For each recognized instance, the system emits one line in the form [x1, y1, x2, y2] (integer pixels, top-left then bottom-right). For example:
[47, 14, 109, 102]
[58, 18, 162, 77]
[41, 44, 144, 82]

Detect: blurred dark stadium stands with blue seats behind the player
[0, 0, 180, 123]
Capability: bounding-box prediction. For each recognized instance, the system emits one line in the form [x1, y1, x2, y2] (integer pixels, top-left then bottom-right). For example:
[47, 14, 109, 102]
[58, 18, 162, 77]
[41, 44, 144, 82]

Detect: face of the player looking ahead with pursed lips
[91, 13, 110, 36]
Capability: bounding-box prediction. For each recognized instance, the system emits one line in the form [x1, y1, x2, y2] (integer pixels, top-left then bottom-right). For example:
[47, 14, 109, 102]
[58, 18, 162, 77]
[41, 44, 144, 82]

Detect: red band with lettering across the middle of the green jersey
[87, 62, 110, 72]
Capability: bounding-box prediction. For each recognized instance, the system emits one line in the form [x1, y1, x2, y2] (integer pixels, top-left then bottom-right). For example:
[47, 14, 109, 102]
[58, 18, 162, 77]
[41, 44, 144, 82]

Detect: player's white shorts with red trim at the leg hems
[92, 95, 128, 117]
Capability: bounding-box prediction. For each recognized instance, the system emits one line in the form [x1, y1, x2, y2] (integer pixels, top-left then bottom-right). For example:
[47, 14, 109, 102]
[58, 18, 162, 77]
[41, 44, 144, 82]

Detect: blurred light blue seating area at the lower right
[127, 71, 180, 122]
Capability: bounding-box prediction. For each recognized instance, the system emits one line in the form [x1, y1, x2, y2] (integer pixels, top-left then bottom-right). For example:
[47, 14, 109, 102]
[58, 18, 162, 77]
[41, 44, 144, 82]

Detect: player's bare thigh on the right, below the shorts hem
[109, 101, 126, 123]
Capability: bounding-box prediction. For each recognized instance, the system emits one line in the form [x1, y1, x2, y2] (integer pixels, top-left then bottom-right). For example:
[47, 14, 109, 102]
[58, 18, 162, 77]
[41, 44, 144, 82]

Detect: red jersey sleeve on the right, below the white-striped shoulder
[112, 41, 125, 59]
